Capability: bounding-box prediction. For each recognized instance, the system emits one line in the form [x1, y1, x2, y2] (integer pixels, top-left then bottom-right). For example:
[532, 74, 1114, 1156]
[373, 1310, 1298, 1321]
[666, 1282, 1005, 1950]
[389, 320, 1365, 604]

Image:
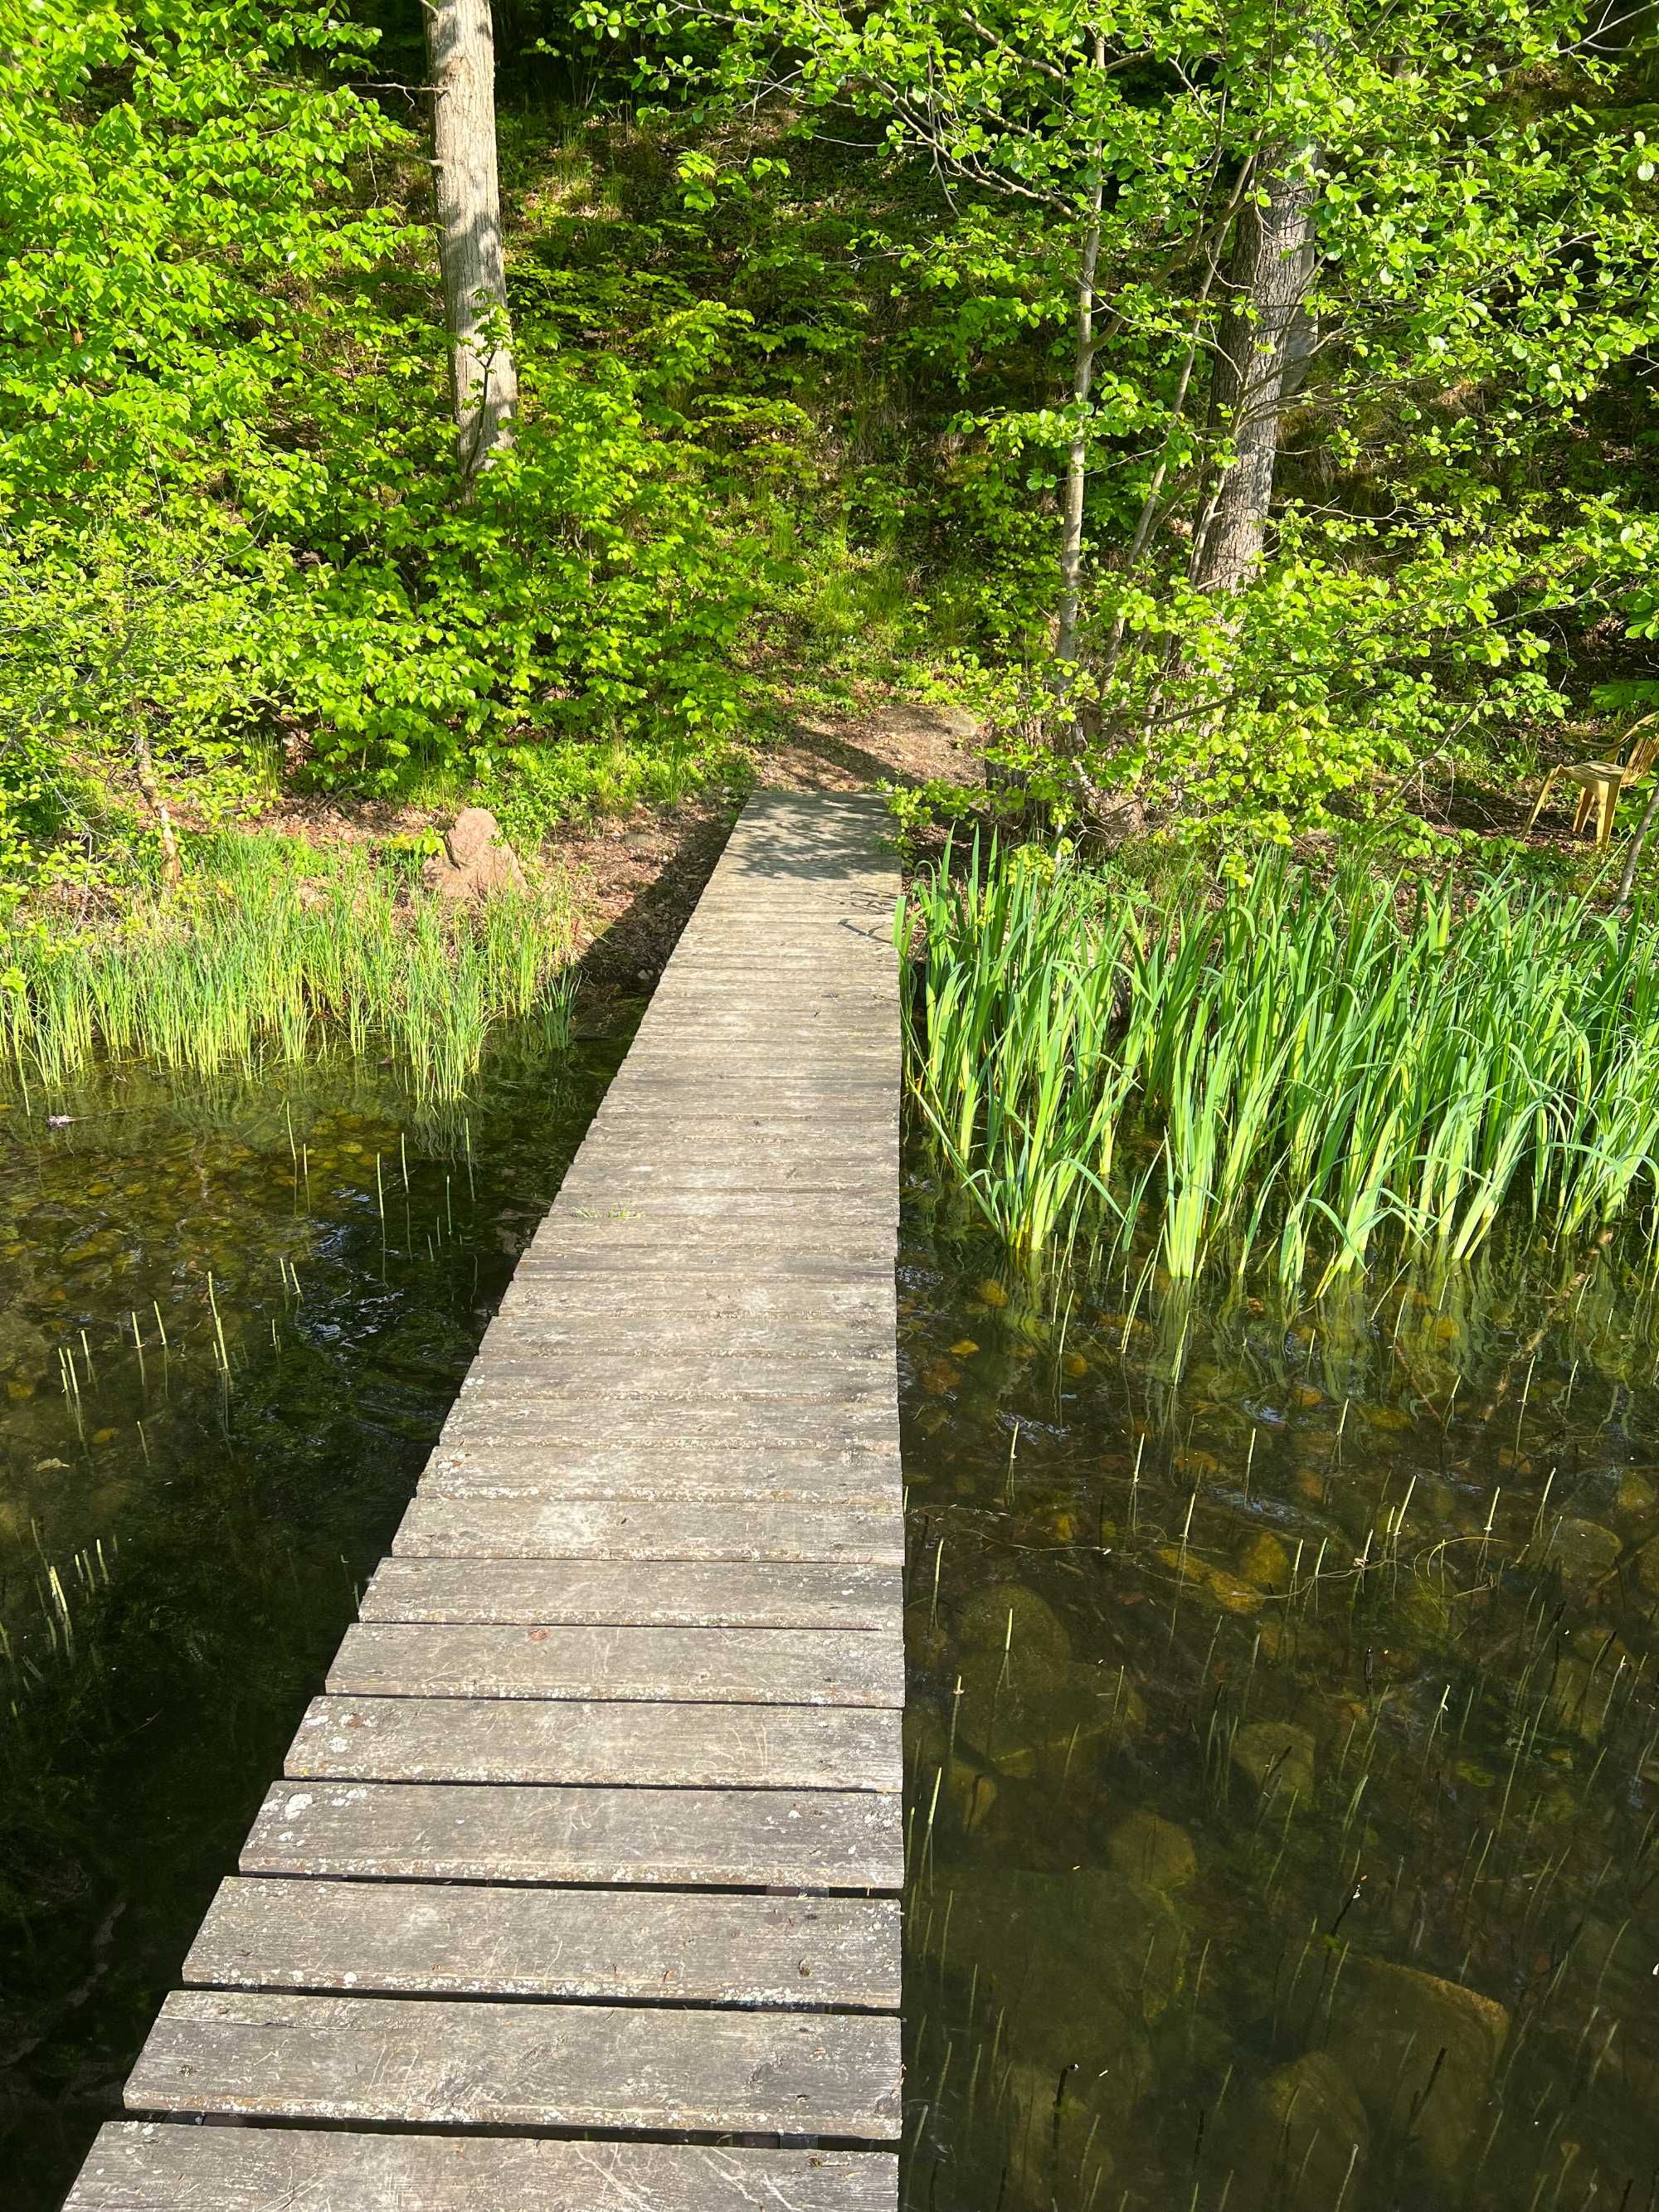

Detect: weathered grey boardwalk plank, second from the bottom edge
[126, 1989, 898, 2142]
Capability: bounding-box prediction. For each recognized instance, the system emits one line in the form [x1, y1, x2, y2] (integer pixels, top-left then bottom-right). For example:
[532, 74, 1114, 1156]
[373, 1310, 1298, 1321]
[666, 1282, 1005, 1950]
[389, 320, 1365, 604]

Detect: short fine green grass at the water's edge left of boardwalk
[0, 836, 575, 1099]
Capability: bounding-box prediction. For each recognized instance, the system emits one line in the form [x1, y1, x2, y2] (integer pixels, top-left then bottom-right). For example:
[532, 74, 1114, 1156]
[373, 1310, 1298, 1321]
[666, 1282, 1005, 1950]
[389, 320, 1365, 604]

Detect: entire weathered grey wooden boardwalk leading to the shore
[69, 794, 905, 2212]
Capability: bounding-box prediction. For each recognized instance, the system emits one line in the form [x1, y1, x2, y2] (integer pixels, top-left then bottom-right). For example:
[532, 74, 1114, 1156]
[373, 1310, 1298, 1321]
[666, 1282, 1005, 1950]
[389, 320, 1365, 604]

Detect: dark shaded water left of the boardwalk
[0, 1024, 626, 2212]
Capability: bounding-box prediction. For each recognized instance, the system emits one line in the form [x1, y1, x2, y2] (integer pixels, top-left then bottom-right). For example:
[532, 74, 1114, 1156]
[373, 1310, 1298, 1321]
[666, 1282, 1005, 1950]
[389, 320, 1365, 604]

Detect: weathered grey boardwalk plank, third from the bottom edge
[183, 1880, 900, 2013]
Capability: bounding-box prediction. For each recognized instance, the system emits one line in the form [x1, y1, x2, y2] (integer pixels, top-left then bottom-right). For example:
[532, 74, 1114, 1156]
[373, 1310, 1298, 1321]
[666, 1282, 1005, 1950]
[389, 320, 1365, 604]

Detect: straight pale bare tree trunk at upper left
[422, 0, 518, 495]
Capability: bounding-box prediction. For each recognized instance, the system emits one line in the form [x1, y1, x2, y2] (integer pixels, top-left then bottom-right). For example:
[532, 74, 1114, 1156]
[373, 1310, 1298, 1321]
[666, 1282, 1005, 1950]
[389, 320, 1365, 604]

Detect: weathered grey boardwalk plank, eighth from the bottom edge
[392, 1493, 905, 1566]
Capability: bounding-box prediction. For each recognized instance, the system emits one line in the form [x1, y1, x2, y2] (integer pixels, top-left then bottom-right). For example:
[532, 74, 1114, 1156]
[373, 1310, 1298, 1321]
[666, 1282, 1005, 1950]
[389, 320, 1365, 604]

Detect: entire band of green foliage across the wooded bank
[0, 0, 1659, 882]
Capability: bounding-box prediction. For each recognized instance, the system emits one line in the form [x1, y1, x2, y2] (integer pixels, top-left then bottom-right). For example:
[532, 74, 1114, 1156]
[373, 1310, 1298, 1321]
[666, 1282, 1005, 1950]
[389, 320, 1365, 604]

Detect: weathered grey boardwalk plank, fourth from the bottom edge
[241, 1781, 905, 1889]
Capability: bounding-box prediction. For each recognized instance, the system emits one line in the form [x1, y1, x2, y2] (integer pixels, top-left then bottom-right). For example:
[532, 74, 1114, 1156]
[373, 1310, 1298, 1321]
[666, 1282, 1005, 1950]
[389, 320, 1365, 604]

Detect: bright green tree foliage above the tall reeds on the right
[606, 0, 1659, 839]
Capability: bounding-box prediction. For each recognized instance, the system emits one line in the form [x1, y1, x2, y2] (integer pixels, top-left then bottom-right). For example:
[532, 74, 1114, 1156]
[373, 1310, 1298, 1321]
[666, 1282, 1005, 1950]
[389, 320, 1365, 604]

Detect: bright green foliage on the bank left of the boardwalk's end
[0, 0, 800, 873]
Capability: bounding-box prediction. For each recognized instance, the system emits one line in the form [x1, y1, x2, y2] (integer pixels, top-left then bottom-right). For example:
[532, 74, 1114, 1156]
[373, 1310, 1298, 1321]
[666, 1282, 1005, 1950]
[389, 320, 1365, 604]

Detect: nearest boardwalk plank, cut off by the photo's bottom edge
[64, 2119, 898, 2212]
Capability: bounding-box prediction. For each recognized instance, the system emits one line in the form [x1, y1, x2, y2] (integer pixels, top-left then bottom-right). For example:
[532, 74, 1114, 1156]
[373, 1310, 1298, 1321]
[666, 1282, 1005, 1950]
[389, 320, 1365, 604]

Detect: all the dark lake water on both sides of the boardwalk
[0, 1057, 1659, 2212]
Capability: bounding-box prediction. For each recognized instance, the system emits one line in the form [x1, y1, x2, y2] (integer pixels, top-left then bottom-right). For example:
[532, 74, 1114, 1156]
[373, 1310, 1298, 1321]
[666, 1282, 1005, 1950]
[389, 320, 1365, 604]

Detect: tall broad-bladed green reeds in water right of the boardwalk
[900, 845, 1659, 1287]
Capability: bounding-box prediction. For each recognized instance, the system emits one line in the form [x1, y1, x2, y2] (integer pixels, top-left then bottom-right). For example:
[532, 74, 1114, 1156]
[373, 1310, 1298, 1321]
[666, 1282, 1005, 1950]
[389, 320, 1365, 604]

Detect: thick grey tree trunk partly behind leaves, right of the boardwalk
[1192, 163, 1318, 591]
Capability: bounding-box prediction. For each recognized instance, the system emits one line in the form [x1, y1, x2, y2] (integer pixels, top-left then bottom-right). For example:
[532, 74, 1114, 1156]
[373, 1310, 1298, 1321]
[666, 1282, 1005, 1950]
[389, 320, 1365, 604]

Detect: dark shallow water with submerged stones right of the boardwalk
[900, 1161, 1659, 2212]
